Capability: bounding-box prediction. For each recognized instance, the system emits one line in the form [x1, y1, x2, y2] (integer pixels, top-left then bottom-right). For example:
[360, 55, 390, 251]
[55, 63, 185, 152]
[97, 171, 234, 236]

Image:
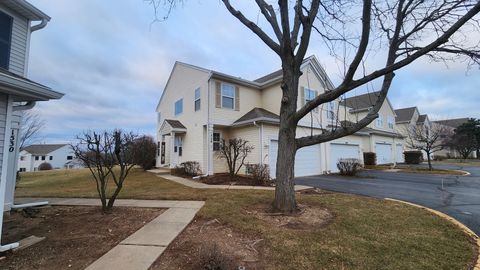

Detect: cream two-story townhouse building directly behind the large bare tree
[156, 56, 403, 176]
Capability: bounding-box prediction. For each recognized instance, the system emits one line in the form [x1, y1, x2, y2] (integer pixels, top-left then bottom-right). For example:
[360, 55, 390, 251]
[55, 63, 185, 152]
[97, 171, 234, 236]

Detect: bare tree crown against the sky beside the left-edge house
[19, 110, 45, 149]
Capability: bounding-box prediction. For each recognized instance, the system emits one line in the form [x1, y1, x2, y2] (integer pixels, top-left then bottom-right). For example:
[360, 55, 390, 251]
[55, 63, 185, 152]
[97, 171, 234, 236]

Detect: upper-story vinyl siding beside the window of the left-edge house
[0, 7, 30, 76]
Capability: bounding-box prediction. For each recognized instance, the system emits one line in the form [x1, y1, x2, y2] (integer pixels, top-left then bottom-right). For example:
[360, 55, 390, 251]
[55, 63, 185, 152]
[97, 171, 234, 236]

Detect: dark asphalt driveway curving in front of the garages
[296, 165, 480, 235]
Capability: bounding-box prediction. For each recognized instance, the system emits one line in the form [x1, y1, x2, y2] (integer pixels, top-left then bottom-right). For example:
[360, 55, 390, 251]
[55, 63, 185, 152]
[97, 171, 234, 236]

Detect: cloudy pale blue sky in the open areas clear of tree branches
[28, 0, 480, 143]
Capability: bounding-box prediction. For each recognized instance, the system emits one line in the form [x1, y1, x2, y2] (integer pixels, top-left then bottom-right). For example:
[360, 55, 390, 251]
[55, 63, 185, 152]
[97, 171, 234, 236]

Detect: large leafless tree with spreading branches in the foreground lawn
[150, 0, 480, 213]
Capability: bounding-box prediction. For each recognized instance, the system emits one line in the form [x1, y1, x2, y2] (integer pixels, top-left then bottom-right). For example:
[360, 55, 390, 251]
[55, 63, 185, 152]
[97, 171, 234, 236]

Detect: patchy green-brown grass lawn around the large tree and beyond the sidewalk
[16, 170, 476, 269]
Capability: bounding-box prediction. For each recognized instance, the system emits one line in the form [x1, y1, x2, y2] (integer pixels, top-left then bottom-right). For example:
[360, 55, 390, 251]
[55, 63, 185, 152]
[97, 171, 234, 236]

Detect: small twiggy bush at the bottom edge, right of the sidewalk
[195, 243, 235, 270]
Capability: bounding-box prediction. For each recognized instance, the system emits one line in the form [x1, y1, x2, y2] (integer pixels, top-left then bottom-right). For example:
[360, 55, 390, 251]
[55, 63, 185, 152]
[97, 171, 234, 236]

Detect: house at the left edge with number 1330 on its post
[0, 0, 63, 235]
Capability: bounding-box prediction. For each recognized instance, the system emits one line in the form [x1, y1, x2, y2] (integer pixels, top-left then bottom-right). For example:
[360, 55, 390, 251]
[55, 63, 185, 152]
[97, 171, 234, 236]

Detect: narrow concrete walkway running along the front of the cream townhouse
[148, 169, 312, 191]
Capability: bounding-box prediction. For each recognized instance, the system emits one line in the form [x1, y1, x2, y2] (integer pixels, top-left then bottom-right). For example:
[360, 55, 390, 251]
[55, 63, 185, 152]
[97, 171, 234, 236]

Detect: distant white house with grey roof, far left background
[18, 144, 81, 172]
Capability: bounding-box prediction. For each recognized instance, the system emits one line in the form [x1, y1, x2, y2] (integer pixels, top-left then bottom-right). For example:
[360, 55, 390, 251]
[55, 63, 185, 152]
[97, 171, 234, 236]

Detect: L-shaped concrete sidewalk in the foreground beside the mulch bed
[16, 198, 204, 270]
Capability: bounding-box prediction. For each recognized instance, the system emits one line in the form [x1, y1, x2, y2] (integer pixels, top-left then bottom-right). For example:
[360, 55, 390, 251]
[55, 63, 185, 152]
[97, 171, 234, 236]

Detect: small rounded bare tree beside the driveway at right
[405, 123, 450, 170]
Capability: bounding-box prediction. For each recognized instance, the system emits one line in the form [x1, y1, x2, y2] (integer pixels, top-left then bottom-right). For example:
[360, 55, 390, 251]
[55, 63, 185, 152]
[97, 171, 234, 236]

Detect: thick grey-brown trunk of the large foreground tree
[273, 56, 300, 214]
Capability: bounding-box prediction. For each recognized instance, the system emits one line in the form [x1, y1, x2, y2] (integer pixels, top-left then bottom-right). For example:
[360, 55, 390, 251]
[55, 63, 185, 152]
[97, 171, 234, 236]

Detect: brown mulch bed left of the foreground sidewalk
[0, 206, 164, 269]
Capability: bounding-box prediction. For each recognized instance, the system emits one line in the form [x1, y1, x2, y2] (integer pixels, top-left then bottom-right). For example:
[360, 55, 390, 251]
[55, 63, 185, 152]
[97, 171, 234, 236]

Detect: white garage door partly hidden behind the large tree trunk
[269, 141, 321, 178]
